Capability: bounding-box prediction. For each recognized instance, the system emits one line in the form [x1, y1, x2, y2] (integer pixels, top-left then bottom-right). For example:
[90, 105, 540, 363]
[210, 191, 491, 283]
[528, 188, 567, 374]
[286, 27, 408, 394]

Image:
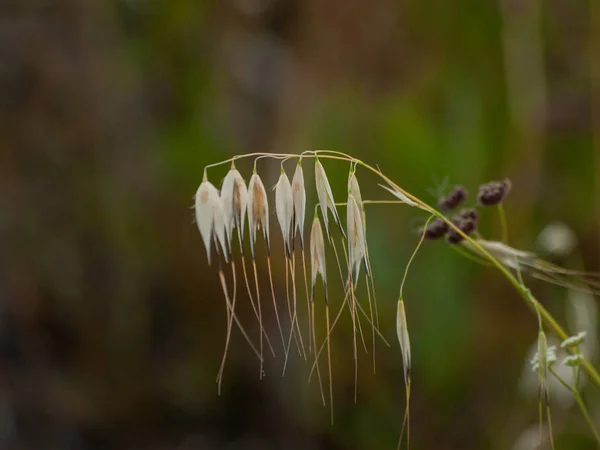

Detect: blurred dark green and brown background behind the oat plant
[0, 0, 600, 450]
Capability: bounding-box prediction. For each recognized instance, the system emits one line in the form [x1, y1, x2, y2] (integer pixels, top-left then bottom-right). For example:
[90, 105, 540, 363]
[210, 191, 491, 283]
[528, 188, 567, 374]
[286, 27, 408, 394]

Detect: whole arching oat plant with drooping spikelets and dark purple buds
[195, 150, 600, 448]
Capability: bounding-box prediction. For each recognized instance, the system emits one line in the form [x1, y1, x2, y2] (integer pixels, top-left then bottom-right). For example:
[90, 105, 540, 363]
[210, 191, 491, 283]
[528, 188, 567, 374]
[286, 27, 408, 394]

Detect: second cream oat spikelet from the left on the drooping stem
[221, 167, 248, 252]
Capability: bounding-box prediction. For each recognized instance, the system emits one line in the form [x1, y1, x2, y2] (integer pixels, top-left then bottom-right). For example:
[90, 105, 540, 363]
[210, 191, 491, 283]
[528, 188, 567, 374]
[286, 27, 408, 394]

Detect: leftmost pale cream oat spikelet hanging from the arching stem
[194, 179, 228, 264]
